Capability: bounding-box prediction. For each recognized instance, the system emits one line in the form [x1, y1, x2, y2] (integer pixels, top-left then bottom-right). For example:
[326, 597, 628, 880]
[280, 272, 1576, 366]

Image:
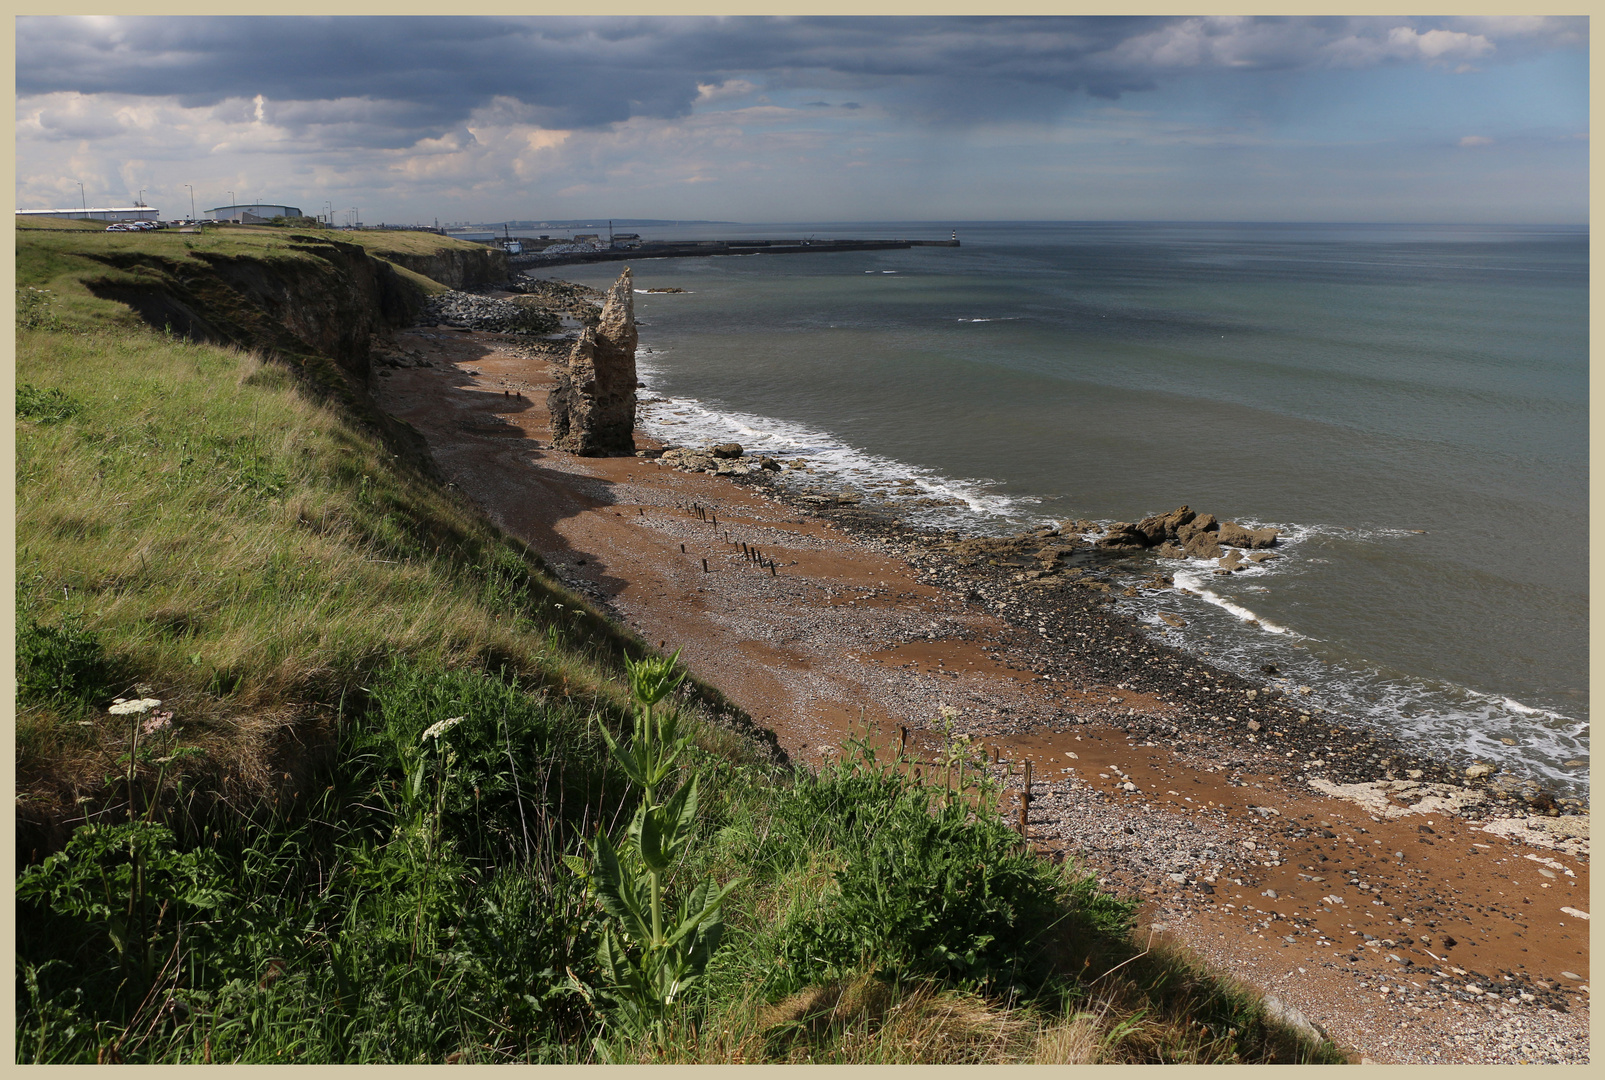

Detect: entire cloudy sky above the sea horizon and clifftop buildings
[16, 16, 1589, 225]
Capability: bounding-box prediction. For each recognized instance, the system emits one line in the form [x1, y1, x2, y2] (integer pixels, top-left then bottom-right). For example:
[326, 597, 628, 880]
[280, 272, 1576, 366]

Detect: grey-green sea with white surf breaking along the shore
[534, 221, 1589, 796]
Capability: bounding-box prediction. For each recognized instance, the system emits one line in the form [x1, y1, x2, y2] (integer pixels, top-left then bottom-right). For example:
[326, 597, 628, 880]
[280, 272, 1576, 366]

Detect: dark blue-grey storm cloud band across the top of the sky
[16, 16, 1586, 146]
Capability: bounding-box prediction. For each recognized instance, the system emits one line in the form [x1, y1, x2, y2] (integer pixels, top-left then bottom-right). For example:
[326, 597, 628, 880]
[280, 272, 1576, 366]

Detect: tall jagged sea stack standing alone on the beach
[546, 266, 637, 457]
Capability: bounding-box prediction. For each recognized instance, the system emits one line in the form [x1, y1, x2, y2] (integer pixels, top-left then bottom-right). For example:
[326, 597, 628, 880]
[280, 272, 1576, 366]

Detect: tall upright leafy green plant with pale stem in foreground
[568, 650, 742, 1058]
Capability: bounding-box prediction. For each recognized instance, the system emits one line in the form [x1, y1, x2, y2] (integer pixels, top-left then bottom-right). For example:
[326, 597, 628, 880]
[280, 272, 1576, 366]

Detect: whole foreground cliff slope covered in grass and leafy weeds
[16, 231, 1340, 1062]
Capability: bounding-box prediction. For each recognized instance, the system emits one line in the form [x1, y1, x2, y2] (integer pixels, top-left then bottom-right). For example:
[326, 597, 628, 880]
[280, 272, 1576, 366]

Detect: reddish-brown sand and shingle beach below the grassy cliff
[374, 322, 1589, 1064]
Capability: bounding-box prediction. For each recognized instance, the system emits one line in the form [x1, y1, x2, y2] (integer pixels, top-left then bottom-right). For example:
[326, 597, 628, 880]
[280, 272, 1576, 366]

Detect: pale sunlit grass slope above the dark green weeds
[16, 320, 670, 828]
